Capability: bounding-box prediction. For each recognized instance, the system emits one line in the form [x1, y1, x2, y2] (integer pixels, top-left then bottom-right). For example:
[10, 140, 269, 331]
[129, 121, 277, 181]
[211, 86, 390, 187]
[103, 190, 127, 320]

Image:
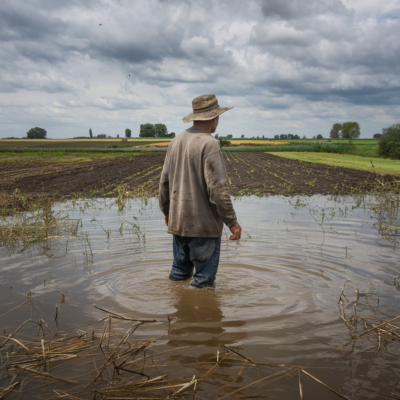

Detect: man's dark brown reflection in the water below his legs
[169, 283, 247, 347]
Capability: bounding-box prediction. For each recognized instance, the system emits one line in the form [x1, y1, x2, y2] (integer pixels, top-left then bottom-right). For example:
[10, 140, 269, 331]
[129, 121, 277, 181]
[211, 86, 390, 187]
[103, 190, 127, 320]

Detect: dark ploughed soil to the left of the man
[0, 153, 165, 203]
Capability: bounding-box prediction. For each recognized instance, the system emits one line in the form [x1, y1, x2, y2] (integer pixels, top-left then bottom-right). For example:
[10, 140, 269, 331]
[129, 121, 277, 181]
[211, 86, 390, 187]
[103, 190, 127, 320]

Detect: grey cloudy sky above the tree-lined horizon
[0, 0, 400, 138]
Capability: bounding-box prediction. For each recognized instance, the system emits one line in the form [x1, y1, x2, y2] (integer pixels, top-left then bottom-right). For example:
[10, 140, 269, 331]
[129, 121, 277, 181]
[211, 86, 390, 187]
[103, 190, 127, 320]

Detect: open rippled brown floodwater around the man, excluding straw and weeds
[0, 196, 400, 399]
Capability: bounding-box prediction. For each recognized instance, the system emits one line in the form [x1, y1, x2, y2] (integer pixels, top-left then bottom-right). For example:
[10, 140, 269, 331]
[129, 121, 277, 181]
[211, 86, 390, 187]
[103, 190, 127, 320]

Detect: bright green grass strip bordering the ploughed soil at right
[269, 152, 400, 175]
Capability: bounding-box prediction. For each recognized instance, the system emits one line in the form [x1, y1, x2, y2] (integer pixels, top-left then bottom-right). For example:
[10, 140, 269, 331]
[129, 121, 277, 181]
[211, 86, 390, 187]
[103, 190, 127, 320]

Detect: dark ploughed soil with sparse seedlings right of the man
[225, 152, 394, 195]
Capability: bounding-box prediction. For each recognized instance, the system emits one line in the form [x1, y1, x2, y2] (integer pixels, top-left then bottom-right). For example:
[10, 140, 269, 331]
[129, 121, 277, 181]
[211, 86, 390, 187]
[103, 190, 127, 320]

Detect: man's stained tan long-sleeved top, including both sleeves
[159, 128, 236, 237]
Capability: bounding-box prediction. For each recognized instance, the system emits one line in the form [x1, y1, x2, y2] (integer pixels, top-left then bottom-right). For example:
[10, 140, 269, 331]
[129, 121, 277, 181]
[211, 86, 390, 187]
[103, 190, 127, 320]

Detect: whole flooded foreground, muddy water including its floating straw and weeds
[0, 195, 400, 400]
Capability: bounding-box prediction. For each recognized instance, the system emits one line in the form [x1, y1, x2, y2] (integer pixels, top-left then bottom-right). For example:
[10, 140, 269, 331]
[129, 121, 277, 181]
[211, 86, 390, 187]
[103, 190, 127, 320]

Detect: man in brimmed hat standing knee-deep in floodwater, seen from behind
[159, 94, 242, 287]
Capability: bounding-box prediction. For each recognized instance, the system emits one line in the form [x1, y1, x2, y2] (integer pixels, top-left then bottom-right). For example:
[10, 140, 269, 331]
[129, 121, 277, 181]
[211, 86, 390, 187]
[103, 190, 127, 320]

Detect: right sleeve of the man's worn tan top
[204, 150, 237, 227]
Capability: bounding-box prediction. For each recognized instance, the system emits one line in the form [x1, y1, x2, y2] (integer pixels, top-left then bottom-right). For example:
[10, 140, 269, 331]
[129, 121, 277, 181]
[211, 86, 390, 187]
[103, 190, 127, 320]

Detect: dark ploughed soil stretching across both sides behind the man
[0, 152, 394, 207]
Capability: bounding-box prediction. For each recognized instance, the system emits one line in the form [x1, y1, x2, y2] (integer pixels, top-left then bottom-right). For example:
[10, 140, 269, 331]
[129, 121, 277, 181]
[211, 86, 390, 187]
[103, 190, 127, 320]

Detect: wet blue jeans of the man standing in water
[169, 235, 221, 287]
